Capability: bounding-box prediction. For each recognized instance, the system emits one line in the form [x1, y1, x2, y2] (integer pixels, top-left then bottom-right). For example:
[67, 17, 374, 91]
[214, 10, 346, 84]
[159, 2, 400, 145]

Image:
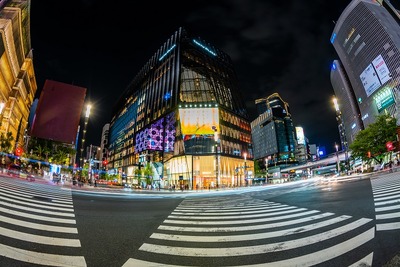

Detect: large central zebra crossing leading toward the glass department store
[123, 195, 375, 267]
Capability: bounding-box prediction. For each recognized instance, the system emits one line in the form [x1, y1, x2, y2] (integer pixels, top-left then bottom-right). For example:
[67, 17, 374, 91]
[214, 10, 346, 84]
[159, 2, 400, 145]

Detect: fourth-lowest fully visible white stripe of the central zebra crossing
[164, 210, 320, 225]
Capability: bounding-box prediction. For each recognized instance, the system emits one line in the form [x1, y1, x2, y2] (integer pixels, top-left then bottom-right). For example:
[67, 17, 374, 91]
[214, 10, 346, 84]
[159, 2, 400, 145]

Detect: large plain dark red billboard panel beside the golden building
[31, 80, 86, 144]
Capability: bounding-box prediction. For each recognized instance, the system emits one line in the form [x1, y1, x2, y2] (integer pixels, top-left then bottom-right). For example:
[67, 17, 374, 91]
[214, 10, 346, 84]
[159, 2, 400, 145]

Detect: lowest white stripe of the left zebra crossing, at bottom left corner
[0, 244, 86, 267]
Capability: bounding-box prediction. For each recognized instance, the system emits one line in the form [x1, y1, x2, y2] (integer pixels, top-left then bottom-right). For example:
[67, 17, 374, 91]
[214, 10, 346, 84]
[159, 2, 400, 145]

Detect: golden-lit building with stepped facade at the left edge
[0, 0, 37, 152]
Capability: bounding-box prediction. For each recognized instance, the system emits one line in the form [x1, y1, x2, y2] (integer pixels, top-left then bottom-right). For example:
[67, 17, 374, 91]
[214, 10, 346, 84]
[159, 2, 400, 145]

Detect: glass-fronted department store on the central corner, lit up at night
[109, 28, 254, 189]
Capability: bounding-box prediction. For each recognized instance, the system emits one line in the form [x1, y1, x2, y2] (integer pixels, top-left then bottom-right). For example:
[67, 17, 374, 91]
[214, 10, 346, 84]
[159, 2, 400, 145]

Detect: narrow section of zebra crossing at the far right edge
[371, 172, 400, 231]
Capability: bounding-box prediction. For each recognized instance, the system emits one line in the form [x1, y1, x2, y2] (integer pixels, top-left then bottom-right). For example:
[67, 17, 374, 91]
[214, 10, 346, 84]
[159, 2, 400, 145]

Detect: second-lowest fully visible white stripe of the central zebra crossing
[150, 215, 351, 242]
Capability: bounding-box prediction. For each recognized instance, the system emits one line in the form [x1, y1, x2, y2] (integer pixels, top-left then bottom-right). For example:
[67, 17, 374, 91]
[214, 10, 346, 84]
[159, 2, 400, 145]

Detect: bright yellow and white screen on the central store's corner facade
[179, 108, 220, 135]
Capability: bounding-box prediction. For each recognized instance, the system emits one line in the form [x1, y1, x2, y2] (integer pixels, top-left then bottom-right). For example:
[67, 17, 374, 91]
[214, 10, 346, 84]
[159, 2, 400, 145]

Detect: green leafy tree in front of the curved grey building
[349, 114, 397, 163]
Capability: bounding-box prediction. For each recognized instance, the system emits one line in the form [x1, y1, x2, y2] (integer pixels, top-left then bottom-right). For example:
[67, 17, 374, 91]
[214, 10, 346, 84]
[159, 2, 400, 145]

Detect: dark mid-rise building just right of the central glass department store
[251, 93, 298, 169]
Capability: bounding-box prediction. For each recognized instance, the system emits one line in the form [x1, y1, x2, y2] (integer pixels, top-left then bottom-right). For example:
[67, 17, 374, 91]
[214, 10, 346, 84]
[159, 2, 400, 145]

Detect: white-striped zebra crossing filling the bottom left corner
[0, 177, 86, 267]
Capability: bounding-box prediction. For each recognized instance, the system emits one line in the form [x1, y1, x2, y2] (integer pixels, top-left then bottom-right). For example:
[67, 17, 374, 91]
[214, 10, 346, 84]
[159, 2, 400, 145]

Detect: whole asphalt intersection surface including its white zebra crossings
[0, 173, 400, 267]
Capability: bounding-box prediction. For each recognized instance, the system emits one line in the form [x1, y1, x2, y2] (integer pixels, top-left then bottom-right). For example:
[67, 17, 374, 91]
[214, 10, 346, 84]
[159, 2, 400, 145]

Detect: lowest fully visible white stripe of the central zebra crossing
[139, 218, 375, 258]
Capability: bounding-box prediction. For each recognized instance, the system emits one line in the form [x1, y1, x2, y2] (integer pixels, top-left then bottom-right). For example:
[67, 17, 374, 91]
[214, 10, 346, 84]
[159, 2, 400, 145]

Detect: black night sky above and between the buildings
[31, 0, 350, 155]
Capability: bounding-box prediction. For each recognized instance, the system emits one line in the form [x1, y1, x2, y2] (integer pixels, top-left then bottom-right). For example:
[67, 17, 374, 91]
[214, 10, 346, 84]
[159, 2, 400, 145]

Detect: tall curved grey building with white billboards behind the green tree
[330, 0, 400, 144]
